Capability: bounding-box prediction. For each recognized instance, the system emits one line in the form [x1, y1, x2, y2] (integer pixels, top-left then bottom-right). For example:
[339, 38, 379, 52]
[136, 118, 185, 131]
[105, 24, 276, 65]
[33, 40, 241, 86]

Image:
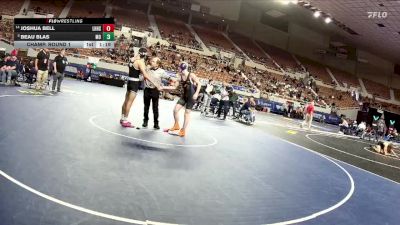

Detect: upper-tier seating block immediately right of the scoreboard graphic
[112, 8, 150, 31]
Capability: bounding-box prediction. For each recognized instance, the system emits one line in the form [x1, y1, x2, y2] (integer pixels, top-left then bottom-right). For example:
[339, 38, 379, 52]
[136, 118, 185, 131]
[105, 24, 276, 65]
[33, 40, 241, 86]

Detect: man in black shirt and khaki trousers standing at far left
[35, 48, 50, 90]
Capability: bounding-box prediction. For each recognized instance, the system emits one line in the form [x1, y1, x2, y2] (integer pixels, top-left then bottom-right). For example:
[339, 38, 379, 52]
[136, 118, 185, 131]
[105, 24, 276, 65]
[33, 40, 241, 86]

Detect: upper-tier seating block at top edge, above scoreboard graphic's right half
[68, 0, 106, 18]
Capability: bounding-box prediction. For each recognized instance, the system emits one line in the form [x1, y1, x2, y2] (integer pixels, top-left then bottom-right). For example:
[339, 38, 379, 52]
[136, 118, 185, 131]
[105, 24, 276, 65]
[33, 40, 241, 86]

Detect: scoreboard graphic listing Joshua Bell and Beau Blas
[14, 18, 115, 48]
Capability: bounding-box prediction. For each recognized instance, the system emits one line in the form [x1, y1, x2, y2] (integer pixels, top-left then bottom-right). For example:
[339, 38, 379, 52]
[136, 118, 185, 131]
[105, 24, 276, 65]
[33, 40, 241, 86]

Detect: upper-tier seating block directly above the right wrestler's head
[155, 16, 201, 49]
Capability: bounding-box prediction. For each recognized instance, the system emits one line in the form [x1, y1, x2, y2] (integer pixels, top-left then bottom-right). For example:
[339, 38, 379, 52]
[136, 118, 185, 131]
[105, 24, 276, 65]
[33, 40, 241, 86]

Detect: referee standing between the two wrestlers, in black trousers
[142, 57, 169, 130]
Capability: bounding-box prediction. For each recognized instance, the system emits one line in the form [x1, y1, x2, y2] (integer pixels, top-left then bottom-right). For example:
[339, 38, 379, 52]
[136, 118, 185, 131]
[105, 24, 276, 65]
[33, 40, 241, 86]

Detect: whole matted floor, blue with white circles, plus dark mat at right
[0, 79, 400, 225]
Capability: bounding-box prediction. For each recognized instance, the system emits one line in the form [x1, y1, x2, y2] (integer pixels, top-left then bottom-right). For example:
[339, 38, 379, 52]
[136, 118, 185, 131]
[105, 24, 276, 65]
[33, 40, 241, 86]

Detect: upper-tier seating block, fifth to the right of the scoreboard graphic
[257, 41, 301, 72]
